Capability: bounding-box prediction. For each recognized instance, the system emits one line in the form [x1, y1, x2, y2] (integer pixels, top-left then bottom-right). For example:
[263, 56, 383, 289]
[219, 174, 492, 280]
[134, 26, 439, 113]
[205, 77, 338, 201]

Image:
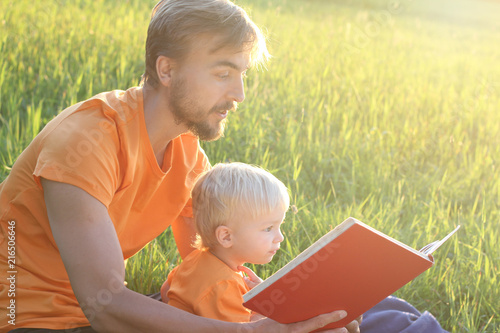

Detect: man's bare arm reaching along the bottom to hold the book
[42, 179, 356, 333]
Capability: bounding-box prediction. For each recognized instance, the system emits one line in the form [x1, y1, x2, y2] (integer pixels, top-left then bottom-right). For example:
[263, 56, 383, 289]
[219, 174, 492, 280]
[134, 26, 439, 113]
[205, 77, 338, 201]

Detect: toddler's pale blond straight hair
[192, 162, 290, 249]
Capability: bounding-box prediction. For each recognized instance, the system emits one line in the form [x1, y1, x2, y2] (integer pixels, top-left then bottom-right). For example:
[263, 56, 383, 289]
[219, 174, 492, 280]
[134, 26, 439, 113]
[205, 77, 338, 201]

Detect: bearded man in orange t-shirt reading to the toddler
[0, 0, 359, 332]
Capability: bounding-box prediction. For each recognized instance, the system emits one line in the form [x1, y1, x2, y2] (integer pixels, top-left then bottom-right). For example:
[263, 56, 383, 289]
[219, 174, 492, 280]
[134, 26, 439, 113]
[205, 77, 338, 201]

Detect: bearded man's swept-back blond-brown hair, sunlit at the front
[141, 0, 270, 87]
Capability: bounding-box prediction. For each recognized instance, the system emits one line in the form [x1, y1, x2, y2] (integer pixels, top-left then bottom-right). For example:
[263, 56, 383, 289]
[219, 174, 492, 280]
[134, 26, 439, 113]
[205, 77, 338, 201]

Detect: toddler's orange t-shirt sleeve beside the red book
[194, 281, 251, 323]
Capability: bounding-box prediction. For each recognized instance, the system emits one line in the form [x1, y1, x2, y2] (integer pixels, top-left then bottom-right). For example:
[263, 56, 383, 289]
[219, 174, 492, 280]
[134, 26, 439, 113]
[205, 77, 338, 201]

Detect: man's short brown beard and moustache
[170, 80, 237, 141]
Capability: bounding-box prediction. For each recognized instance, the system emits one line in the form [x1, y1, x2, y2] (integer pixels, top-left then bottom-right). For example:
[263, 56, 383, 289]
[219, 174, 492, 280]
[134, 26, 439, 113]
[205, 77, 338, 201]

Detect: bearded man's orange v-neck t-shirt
[0, 87, 210, 331]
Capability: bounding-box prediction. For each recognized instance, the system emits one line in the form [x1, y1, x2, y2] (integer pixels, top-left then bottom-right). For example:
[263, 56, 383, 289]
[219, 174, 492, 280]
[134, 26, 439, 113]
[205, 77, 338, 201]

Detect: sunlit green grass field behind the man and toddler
[0, 0, 500, 332]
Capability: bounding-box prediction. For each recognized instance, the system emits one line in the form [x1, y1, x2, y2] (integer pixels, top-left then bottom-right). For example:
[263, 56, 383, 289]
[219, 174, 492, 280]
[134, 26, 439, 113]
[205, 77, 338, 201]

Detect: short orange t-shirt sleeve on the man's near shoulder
[33, 110, 119, 207]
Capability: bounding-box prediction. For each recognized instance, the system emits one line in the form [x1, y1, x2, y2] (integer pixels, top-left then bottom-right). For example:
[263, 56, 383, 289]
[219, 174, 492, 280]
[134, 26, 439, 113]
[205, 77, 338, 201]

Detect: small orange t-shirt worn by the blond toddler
[167, 250, 251, 323]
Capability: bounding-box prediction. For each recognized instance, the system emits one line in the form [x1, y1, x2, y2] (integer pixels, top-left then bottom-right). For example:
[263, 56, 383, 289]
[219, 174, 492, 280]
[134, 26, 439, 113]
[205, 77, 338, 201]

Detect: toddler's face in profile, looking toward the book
[230, 208, 286, 265]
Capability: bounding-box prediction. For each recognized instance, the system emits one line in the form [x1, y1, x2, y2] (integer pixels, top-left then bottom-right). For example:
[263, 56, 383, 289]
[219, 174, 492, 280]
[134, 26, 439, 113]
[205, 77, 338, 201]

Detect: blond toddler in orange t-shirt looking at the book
[162, 163, 290, 322]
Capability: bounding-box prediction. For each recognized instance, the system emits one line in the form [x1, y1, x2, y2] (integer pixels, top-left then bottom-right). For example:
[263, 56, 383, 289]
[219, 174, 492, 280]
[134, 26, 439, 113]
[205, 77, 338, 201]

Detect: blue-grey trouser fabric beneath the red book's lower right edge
[360, 296, 447, 333]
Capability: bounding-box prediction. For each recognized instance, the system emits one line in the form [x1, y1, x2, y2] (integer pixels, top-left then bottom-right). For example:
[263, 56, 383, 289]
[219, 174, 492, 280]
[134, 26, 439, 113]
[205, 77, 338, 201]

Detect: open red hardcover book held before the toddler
[243, 217, 460, 329]
